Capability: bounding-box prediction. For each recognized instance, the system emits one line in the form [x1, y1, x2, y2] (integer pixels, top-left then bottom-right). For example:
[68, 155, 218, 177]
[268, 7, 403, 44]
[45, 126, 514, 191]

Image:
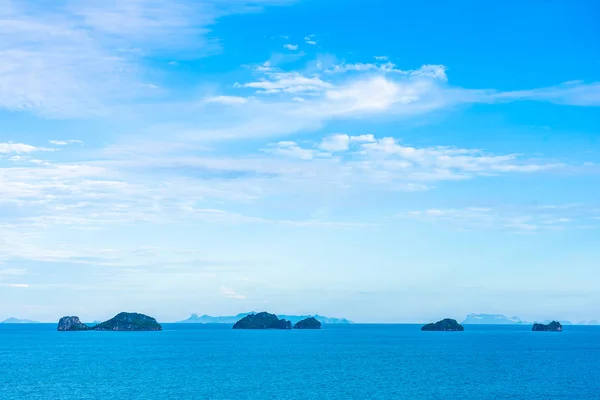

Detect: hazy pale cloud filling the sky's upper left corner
[0, 0, 300, 117]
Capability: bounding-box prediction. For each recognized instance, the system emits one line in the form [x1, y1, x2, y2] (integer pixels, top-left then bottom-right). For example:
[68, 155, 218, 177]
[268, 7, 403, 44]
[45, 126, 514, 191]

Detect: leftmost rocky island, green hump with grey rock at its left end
[57, 312, 162, 331]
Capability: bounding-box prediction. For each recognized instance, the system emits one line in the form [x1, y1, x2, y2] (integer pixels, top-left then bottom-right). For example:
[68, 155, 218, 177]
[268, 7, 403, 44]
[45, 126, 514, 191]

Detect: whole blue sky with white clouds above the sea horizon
[0, 0, 600, 322]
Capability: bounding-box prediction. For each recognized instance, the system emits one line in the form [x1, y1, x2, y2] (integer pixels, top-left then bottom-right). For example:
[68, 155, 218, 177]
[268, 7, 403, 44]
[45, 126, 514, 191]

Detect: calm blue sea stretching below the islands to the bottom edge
[0, 324, 600, 400]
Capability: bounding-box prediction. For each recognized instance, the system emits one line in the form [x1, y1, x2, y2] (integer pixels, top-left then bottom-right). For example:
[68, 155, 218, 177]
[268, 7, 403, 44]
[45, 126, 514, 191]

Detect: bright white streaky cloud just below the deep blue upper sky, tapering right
[176, 61, 591, 147]
